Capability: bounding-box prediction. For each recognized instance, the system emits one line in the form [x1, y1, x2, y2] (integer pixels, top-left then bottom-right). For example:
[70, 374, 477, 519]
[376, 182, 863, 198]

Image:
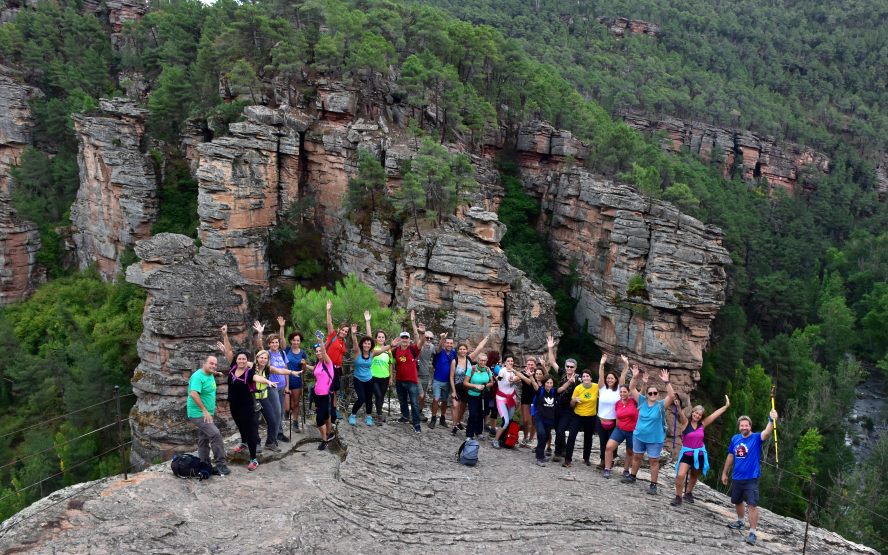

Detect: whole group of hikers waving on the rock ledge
[187, 301, 777, 544]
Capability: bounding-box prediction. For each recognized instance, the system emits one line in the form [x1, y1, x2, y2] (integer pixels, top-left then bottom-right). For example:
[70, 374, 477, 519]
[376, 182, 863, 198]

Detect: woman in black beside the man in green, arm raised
[216, 326, 276, 472]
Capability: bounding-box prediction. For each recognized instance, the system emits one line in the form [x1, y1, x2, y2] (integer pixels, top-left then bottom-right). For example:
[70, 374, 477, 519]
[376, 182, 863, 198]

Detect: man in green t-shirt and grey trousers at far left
[186, 355, 231, 476]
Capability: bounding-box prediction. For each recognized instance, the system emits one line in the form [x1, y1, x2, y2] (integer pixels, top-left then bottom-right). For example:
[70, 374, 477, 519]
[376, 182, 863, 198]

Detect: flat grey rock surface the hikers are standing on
[0, 419, 874, 554]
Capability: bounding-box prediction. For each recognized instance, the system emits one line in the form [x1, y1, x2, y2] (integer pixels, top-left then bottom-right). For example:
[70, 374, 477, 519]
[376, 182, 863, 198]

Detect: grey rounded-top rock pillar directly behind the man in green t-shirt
[126, 233, 248, 468]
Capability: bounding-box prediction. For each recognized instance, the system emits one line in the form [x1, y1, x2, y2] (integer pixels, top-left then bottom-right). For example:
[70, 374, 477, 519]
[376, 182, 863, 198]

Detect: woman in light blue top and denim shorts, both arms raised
[621, 367, 675, 495]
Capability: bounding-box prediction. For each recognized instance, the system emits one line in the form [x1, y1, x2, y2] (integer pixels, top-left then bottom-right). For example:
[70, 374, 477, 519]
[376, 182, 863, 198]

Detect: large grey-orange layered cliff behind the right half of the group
[519, 123, 730, 390]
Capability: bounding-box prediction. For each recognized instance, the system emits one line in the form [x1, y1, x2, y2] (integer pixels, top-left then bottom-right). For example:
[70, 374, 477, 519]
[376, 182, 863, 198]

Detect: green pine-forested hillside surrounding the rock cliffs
[0, 0, 888, 549]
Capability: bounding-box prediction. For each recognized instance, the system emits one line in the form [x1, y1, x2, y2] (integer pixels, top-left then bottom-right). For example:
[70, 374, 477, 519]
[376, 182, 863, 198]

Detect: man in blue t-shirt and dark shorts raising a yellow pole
[722, 410, 777, 545]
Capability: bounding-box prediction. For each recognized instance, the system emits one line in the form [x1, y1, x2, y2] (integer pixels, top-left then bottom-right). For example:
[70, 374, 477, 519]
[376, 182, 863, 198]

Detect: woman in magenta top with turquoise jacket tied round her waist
[670, 395, 731, 506]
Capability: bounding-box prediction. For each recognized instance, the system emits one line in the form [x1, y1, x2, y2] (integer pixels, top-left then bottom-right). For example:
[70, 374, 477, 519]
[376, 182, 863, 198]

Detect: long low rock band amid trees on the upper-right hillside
[620, 112, 829, 193]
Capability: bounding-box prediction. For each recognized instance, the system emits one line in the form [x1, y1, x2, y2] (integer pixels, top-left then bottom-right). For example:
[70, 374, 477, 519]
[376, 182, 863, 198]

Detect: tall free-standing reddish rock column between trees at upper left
[71, 98, 158, 279]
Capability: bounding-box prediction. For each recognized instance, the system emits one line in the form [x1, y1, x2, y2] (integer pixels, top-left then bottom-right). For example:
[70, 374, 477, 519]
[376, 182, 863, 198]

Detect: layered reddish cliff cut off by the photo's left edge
[0, 65, 41, 306]
